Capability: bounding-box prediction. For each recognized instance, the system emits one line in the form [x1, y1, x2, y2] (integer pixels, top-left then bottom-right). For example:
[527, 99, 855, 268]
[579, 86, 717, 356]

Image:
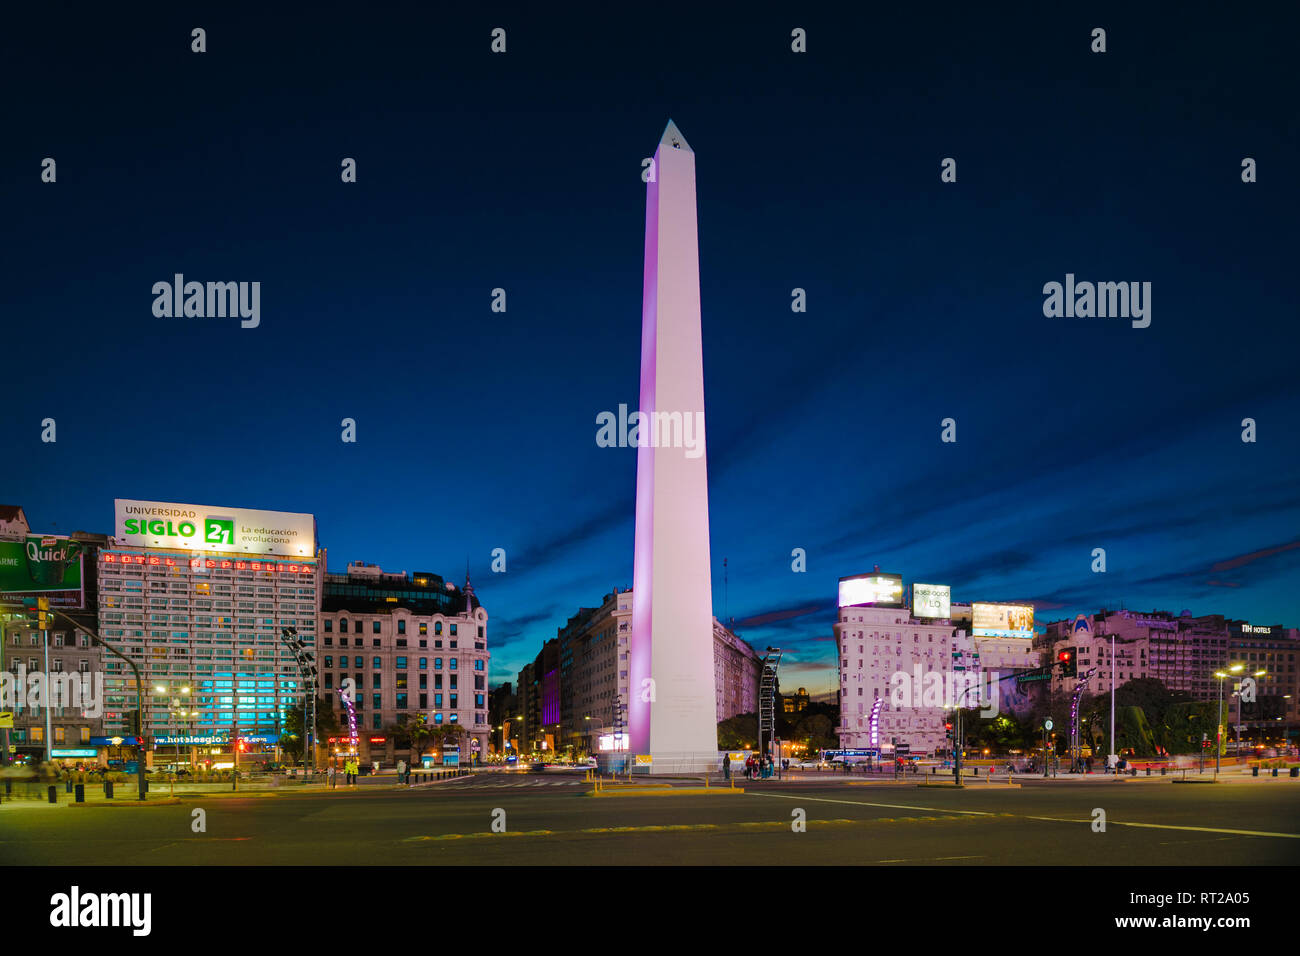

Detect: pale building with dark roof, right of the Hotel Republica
[317, 563, 491, 766]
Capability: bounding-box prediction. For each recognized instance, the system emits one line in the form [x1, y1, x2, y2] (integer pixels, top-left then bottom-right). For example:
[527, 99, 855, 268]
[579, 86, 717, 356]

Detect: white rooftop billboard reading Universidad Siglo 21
[113, 498, 316, 557]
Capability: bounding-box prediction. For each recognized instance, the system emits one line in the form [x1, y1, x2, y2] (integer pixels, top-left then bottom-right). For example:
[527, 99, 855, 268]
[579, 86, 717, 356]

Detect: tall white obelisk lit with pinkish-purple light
[628, 120, 718, 773]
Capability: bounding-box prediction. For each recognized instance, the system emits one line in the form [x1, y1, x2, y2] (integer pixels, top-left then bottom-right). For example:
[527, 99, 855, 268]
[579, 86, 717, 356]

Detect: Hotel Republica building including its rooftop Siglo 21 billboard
[96, 499, 324, 766]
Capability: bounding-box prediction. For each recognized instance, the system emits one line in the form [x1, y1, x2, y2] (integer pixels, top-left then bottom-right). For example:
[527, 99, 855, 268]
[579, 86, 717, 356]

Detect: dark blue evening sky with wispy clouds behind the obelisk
[0, 4, 1300, 691]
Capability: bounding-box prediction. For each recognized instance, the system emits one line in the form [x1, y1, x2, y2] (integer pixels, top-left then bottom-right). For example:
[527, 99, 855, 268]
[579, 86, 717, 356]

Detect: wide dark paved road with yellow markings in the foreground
[0, 774, 1300, 866]
